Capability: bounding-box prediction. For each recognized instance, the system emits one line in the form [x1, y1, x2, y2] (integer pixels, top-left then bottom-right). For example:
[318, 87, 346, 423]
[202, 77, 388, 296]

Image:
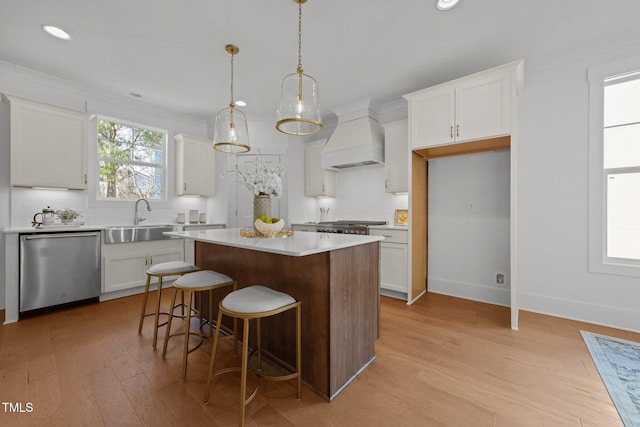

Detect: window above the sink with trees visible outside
[97, 119, 167, 200]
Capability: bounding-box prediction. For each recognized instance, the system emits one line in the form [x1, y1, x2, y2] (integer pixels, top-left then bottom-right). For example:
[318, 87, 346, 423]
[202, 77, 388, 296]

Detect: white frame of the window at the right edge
[587, 58, 640, 277]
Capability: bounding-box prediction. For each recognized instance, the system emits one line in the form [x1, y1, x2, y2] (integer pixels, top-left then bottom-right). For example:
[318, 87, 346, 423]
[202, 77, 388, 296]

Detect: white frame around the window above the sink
[88, 114, 171, 208]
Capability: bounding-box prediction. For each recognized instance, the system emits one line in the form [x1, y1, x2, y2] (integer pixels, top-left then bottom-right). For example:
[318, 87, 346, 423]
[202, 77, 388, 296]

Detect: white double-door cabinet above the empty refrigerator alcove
[405, 62, 521, 150]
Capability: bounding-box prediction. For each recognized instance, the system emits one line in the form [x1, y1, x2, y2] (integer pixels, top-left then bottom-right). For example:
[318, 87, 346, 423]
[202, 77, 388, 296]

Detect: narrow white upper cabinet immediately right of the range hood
[383, 120, 409, 193]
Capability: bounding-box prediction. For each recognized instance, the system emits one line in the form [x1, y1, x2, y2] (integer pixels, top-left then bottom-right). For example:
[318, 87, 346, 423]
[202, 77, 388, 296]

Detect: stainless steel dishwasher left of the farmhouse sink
[20, 231, 101, 314]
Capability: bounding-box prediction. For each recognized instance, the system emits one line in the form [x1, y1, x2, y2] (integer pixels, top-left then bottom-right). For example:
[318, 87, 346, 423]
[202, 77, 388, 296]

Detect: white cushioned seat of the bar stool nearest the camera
[224, 284, 296, 314]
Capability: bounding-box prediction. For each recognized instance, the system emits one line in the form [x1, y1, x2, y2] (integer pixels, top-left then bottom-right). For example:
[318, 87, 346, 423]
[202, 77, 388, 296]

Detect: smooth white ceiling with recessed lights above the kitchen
[0, 0, 640, 117]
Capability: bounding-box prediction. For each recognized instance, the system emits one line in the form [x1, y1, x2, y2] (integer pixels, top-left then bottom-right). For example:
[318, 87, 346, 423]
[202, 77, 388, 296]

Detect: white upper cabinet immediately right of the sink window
[173, 134, 216, 197]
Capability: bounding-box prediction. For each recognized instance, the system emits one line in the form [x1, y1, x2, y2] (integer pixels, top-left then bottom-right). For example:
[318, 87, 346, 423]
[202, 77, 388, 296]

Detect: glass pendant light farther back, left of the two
[213, 44, 251, 154]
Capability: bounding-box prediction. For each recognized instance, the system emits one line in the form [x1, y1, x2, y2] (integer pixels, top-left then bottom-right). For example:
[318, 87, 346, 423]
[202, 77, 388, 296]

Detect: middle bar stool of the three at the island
[162, 270, 237, 380]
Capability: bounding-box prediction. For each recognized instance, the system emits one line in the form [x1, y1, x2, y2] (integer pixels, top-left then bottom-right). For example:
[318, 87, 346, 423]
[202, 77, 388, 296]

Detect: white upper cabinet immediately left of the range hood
[304, 139, 336, 197]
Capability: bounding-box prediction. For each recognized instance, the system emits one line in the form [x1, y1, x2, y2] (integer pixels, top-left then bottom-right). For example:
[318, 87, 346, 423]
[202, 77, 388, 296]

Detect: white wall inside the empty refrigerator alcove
[428, 150, 510, 305]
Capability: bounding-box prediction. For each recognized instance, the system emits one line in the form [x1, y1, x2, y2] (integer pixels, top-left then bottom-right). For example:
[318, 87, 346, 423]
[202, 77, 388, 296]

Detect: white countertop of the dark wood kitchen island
[164, 228, 384, 256]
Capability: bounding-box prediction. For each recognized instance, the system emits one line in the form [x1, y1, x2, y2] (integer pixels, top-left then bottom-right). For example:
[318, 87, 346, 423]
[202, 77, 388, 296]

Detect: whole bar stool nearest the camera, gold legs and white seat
[204, 285, 302, 426]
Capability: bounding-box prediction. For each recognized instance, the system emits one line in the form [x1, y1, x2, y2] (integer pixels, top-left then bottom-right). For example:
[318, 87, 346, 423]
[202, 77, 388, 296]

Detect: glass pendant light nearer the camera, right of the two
[276, 0, 322, 135]
